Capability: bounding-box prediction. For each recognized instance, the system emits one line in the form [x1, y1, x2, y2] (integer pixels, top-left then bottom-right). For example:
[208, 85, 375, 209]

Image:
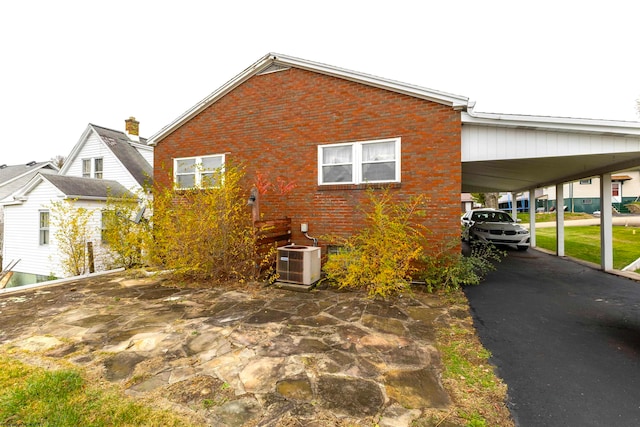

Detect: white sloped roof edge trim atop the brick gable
[148, 53, 469, 146]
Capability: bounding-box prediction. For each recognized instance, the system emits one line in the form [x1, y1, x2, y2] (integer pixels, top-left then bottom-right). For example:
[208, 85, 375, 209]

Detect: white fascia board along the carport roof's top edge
[462, 110, 640, 136]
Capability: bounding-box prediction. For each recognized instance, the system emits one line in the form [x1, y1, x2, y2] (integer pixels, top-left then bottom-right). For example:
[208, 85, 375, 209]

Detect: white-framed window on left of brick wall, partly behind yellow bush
[173, 154, 224, 188]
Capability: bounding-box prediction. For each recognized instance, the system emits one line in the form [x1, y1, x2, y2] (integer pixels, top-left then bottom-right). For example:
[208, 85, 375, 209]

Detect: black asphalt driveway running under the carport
[465, 250, 640, 427]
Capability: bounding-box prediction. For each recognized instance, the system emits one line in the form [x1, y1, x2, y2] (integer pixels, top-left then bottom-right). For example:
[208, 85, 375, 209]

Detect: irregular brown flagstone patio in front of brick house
[0, 274, 467, 427]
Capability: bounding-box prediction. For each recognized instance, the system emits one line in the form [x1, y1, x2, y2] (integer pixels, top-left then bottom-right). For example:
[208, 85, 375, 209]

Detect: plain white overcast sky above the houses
[0, 0, 640, 164]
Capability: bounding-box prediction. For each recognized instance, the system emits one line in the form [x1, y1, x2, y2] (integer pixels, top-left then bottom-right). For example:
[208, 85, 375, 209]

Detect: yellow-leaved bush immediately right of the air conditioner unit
[324, 190, 426, 298]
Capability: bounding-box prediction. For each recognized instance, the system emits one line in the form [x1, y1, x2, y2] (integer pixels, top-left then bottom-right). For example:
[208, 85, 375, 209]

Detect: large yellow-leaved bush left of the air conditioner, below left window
[153, 164, 268, 282]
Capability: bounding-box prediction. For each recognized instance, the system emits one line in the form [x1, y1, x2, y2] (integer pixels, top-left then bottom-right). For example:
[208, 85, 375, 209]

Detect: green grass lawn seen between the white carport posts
[536, 225, 640, 270]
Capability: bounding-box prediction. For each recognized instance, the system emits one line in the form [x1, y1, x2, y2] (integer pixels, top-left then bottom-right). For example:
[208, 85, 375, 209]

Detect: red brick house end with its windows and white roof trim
[149, 53, 468, 254]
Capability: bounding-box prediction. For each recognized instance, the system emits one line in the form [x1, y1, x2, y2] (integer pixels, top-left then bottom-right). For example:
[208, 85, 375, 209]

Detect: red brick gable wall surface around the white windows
[154, 69, 461, 252]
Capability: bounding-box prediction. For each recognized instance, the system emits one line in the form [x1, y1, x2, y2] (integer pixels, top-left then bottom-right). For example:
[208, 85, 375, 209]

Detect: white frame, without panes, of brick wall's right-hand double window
[318, 137, 402, 185]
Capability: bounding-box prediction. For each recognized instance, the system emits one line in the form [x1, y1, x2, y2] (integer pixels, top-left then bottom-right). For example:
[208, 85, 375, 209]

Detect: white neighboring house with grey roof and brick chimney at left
[0, 117, 153, 286]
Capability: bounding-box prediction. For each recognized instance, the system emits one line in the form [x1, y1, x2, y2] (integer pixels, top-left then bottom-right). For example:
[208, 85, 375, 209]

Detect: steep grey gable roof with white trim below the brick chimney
[60, 123, 153, 186]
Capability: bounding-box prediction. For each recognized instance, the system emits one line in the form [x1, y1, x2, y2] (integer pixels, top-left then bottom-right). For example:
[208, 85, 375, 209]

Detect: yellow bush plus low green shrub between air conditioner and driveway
[324, 191, 504, 298]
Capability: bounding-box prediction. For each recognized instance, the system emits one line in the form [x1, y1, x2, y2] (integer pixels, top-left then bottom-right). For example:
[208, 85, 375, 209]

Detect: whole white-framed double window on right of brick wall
[318, 138, 400, 185]
